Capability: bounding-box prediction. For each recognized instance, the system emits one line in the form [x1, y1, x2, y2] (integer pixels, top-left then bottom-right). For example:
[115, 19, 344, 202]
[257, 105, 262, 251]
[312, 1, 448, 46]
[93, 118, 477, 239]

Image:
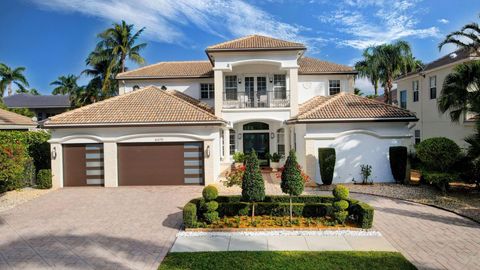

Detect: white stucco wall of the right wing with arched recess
[305, 123, 410, 183]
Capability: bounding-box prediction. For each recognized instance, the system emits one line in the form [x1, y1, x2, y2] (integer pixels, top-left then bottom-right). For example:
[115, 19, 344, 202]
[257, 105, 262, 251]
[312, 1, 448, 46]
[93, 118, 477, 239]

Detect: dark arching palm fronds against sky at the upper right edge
[438, 15, 480, 56]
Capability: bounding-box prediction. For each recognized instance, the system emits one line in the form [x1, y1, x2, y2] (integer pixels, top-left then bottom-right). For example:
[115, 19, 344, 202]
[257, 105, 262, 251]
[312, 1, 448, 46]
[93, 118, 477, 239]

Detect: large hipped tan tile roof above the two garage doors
[45, 86, 224, 127]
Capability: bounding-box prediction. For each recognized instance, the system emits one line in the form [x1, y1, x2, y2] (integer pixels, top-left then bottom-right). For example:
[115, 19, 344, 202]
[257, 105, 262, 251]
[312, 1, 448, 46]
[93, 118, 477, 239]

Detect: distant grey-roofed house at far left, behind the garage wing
[3, 93, 71, 122]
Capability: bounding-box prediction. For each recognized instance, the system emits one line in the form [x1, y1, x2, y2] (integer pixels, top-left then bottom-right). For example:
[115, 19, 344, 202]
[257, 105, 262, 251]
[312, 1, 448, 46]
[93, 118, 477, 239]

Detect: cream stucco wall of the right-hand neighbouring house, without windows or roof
[397, 61, 474, 148]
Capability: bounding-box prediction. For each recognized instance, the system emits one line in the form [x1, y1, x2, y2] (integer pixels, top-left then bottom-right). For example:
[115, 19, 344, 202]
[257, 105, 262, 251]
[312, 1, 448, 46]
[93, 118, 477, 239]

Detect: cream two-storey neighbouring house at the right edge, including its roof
[396, 50, 476, 147]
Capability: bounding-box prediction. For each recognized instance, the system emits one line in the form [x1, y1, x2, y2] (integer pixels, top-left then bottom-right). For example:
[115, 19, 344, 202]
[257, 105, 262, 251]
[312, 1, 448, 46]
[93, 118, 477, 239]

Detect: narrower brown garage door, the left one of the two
[63, 144, 104, 187]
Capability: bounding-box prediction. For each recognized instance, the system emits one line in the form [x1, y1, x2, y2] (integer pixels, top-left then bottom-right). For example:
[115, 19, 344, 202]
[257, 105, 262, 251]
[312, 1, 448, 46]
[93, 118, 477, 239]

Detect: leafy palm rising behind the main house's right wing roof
[367, 41, 417, 104]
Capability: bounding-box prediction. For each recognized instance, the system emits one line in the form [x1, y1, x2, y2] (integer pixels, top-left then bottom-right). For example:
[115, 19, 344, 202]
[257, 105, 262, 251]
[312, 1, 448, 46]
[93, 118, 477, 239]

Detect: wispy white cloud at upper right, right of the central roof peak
[319, 0, 439, 49]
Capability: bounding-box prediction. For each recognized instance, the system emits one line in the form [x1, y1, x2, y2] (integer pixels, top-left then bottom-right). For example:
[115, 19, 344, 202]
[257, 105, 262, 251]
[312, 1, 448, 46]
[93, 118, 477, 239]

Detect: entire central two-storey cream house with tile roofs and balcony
[45, 35, 417, 187]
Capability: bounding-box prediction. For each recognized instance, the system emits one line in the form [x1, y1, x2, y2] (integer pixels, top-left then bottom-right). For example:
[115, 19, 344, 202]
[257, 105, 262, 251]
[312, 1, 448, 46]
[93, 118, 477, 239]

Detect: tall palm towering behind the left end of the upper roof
[94, 21, 147, 93]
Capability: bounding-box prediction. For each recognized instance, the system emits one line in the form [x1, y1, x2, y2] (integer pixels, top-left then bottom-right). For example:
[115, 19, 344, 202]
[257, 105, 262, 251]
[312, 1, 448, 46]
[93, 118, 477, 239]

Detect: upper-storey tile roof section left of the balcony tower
[117, 61, 213, 79]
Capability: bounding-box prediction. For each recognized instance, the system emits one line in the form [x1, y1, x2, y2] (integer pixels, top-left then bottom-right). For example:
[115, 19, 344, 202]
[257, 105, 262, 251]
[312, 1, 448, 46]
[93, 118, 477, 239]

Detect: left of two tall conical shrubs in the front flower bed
[242, 151, 265, 221]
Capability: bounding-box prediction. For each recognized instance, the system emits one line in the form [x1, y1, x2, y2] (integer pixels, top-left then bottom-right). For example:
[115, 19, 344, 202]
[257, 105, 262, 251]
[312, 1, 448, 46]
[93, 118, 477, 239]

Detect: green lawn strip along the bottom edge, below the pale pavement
[158, 251, 416, 270]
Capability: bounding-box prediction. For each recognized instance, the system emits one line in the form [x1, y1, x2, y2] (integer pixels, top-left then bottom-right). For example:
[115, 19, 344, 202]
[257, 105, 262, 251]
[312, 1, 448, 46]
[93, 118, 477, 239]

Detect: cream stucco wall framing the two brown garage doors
[49, 126, 221, 188]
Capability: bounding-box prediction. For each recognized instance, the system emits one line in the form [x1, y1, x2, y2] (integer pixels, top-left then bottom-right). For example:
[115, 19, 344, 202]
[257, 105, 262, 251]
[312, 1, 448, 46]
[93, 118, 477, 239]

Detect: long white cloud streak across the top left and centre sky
[32, 0, 323, 50]
